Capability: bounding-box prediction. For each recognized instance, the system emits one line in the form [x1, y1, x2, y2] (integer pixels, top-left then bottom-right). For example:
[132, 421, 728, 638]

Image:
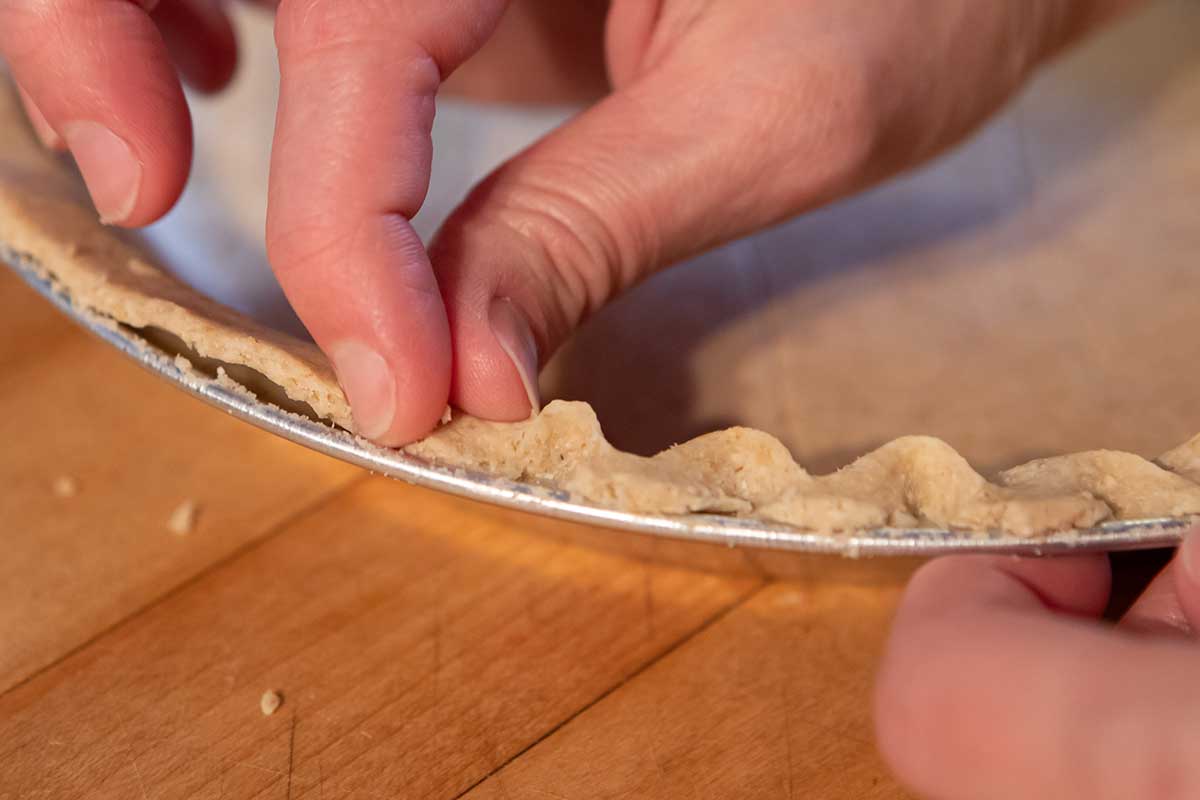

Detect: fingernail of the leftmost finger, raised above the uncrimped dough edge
[62, 121, 142, 224]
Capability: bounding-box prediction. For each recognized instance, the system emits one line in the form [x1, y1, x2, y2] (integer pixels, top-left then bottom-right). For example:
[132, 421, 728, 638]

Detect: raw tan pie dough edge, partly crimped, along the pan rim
[0, 84, 1200, 535]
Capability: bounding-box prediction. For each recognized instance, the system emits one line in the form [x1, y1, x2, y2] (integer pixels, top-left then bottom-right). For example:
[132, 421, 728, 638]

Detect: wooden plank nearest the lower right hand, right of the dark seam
[467, 584, 905, 800]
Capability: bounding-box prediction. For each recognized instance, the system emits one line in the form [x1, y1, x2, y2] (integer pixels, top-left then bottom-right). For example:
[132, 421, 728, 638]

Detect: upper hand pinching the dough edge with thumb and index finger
[0, 0, 1135, 445]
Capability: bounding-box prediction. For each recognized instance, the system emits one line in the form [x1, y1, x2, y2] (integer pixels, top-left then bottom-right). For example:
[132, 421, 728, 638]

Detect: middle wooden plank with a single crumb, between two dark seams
[0, 480, 757, 800]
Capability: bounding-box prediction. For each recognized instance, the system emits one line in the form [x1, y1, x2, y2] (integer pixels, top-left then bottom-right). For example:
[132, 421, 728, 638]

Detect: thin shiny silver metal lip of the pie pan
[9, 250, 1200, 558]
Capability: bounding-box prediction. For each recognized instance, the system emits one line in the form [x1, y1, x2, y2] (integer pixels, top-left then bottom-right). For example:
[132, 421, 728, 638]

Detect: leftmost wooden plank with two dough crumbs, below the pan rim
[0, 270, 360, 691]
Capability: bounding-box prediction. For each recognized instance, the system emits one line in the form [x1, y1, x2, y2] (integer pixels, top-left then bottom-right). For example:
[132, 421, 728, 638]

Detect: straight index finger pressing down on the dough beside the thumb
[266, 0, 505, 445]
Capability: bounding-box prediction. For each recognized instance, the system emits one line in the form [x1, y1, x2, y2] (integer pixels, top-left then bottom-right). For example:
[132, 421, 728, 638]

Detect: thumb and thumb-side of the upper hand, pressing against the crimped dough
[430, 0, 1133, 420]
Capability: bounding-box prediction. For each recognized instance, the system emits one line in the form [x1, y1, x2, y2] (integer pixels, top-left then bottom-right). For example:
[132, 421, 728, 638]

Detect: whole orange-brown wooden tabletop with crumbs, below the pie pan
[0, 262, 907, 800]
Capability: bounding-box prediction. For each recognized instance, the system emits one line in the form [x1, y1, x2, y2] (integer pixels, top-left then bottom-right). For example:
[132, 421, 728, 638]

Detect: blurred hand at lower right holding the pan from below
[876, 535, 1200, 800]
